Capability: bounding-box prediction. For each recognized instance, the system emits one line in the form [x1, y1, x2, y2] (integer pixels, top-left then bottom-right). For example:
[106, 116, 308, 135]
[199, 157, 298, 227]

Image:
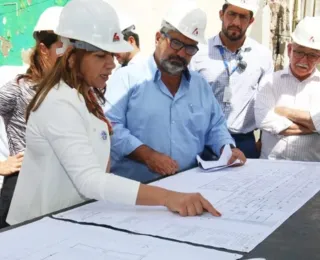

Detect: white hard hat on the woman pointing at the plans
[55, 0, 133, 53]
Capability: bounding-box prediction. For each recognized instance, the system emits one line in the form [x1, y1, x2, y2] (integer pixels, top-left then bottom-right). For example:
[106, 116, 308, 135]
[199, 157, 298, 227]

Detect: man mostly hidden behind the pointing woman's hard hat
[114, 13, 141, 67]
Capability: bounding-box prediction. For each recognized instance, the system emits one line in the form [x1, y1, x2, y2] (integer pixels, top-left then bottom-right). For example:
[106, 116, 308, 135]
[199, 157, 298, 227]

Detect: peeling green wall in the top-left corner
[0, 0, 69, 66]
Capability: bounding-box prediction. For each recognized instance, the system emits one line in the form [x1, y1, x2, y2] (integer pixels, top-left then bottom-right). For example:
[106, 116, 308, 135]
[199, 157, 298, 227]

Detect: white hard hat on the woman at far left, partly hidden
[33, 6, 63, 36]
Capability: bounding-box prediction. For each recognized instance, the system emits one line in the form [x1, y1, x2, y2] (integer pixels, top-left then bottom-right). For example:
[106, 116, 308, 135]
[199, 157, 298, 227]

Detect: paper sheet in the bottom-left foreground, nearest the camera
[0, 218, 241, 260]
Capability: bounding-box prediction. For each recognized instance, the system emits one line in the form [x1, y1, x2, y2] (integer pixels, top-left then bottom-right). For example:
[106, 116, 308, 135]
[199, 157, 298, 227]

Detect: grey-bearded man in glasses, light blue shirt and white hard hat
[106, 1, 246, 181]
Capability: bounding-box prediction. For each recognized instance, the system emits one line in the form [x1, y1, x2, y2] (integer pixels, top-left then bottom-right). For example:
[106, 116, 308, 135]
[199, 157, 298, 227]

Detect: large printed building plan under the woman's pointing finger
[53, 160, 320, 252]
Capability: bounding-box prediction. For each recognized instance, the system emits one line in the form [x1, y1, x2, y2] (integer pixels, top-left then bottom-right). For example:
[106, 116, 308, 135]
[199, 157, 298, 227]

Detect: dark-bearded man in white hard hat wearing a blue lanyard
[191, 0, 273, 158]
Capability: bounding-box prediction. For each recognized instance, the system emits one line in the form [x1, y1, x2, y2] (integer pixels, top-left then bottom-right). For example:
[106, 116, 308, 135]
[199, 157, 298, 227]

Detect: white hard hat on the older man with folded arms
[292, 16, 320, 50]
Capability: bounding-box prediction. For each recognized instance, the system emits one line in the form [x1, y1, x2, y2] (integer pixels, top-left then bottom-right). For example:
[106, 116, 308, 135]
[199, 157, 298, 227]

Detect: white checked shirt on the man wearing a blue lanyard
[190, 35, 273, 134]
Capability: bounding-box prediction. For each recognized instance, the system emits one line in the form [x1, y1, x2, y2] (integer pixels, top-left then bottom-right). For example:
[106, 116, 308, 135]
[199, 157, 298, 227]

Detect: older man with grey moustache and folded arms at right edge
[255, 17, 320, 162]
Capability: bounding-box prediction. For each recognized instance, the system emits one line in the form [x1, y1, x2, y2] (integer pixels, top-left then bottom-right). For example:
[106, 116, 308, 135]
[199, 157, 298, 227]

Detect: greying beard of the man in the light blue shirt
[160, 55, 188, 76]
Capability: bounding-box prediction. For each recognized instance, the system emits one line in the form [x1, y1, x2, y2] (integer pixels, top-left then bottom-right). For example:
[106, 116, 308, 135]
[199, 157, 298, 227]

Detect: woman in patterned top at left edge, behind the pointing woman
[0, 7, 62, 228]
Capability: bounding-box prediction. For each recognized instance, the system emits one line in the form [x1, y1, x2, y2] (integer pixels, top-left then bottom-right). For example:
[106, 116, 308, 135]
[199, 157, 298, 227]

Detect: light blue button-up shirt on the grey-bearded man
[105, 56, 234, 182]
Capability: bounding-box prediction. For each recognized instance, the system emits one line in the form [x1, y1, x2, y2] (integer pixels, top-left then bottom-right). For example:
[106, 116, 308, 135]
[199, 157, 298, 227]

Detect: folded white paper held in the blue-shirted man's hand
[197, 145, 240, 172]
